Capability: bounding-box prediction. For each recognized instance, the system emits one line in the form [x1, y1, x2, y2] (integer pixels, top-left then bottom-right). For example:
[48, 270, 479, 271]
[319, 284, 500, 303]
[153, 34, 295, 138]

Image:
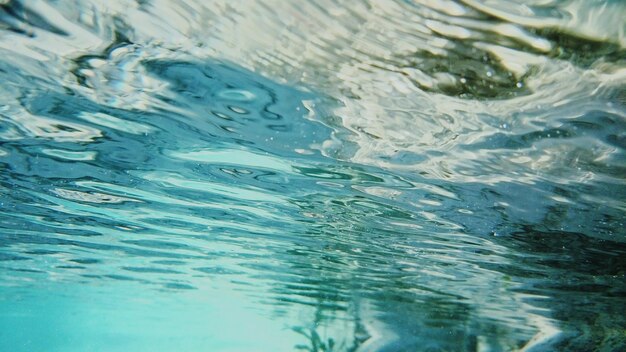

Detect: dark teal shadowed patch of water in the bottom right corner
[498, 224, 626, 351]
